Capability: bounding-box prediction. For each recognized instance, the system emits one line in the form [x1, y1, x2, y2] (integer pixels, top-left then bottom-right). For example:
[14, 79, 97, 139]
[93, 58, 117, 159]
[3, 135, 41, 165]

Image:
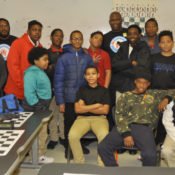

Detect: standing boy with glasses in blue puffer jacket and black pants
[54, 30, 94, 158]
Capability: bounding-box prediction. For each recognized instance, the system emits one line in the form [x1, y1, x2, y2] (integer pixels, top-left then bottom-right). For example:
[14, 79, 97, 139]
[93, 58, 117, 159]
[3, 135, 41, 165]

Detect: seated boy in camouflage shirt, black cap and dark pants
[98, 69, 174, 166]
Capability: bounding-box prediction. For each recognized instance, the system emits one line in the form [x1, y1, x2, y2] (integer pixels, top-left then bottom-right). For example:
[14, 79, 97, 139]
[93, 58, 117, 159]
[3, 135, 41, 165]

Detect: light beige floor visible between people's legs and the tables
[14, 138, 166, 175]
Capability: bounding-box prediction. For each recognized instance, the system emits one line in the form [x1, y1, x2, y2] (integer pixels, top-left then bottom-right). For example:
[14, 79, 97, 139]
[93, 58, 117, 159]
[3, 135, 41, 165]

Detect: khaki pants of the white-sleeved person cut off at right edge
[161, 134, 175, 167]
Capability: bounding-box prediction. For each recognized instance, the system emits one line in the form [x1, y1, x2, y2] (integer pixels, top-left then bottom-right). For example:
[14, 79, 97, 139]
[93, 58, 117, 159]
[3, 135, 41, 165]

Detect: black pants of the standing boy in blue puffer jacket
[64, 103, 77, 148]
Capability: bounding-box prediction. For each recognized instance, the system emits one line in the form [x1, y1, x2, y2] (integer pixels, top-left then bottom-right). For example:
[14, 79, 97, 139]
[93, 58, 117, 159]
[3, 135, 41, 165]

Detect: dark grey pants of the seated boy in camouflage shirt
[98, 124, 157, 166]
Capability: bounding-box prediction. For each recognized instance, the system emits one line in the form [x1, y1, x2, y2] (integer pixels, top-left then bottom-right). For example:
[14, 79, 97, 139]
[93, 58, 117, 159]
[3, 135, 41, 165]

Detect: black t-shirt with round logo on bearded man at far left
[0, 35, 17, 61]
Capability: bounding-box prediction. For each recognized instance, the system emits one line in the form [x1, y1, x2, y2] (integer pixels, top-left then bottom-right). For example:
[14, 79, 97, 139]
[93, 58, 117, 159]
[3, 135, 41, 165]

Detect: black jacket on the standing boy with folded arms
[111, 40, 150, 92]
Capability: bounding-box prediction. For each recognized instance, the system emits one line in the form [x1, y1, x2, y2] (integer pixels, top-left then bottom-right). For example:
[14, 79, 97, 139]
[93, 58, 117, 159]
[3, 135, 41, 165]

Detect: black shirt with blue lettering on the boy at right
[151, 53, 175, 90]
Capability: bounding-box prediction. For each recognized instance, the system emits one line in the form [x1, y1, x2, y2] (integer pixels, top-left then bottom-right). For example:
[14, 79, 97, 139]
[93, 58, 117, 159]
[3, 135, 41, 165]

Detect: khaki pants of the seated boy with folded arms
[68, 116, 109, 166]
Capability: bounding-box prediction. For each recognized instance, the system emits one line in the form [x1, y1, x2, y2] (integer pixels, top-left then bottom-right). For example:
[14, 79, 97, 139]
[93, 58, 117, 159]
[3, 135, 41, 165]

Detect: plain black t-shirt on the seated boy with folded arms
[75, 85, 110, 116]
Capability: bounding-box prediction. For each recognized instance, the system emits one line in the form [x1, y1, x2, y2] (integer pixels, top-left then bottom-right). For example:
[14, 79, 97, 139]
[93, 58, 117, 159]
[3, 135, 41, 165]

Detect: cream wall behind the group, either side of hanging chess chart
[0, 0, 175, 48]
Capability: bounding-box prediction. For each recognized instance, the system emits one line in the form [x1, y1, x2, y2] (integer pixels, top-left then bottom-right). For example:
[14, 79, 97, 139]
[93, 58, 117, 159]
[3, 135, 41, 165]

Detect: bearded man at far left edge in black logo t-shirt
[0, 18, 17, 61]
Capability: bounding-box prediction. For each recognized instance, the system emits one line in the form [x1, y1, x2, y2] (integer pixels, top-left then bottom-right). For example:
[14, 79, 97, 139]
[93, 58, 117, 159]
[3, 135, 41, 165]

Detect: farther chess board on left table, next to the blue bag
[3, 112, 33, 128]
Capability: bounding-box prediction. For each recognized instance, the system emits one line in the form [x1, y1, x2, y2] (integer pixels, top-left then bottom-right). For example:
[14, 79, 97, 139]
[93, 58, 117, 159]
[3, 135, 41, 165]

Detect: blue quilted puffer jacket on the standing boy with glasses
[54, 46, 94, 105]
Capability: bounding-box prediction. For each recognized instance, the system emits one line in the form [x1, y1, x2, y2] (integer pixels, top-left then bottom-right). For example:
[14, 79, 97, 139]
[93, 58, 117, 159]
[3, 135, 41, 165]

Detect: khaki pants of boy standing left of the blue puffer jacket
[49, 96, 65, 142]
